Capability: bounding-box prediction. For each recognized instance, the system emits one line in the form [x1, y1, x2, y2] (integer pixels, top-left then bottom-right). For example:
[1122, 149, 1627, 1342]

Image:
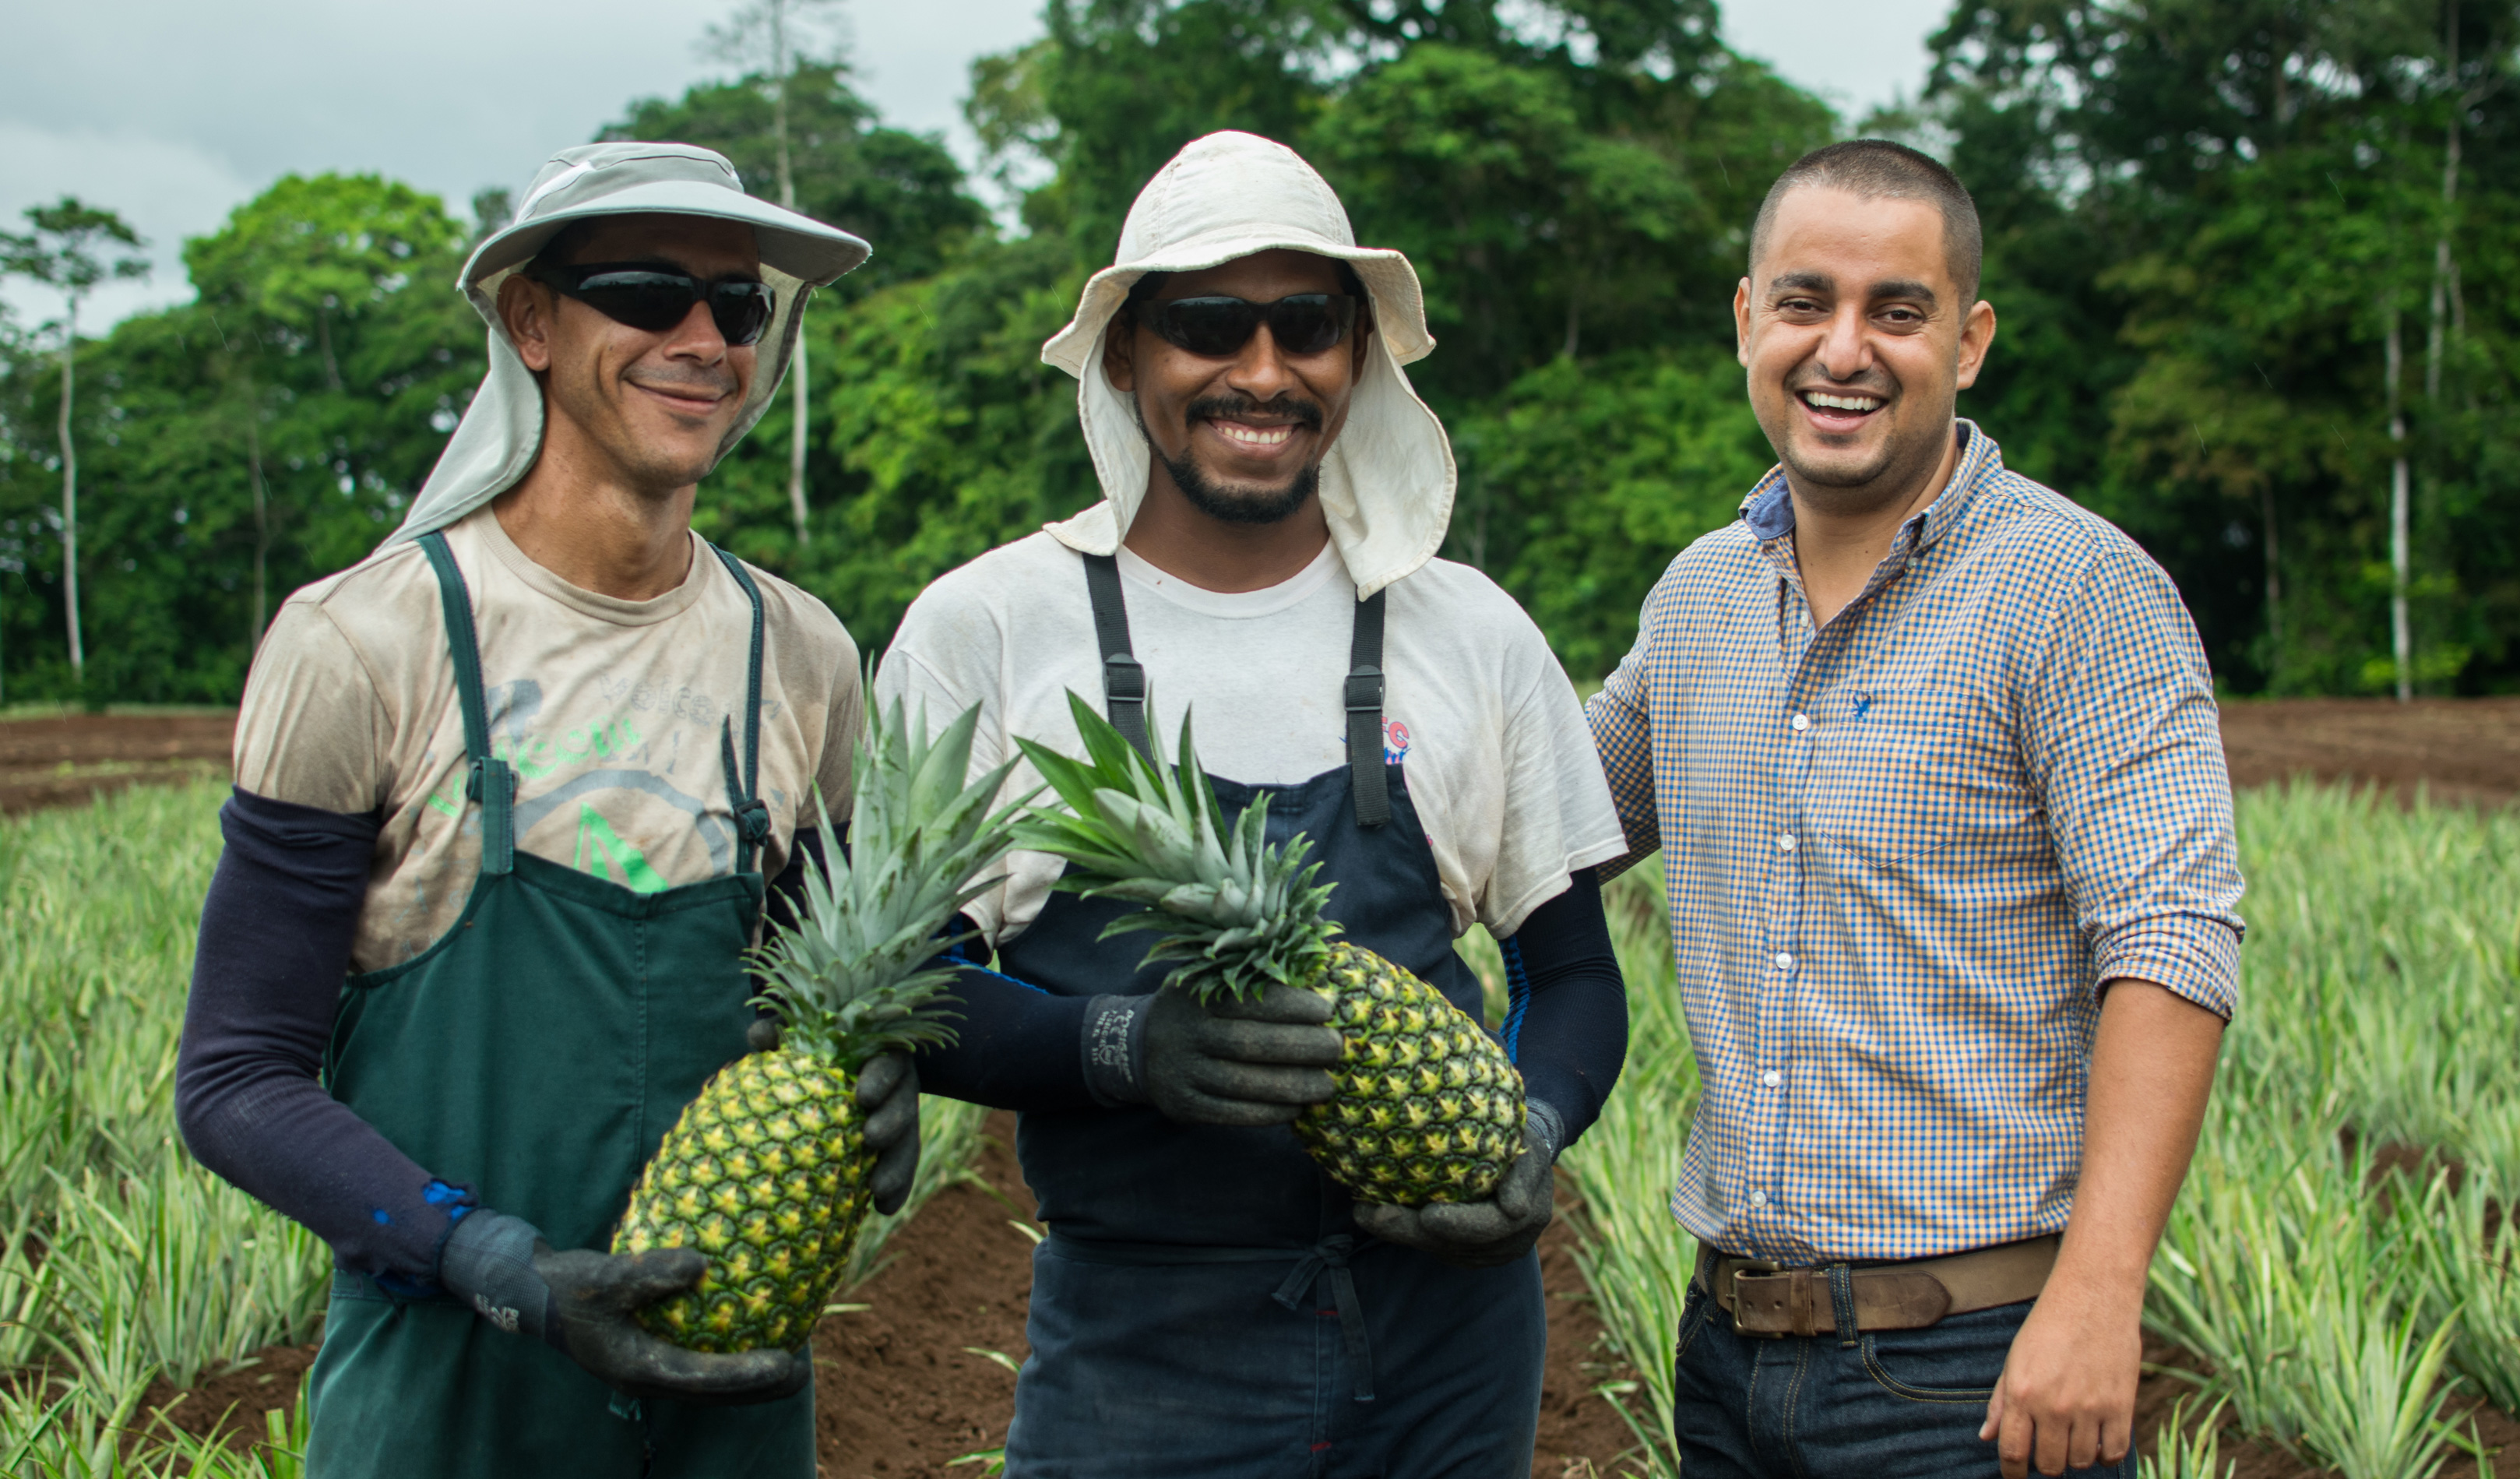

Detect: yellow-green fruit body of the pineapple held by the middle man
[1295, 940, 1522, 1207]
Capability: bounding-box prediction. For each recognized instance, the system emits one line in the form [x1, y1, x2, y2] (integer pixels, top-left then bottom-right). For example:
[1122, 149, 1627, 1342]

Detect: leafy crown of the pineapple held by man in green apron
[746, 700, 1038, 1071]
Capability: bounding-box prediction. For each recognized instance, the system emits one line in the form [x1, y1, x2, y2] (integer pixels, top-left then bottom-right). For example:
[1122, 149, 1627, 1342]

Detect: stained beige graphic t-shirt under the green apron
[237, 509, 862, 970]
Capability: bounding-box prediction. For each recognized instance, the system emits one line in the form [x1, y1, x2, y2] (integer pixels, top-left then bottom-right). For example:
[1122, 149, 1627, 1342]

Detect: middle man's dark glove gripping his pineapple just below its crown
[1086, 985, 1346, 1126]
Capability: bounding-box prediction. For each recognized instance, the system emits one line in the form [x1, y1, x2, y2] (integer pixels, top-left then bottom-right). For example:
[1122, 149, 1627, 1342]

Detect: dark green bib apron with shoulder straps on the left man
[308, 534, 814, 1479]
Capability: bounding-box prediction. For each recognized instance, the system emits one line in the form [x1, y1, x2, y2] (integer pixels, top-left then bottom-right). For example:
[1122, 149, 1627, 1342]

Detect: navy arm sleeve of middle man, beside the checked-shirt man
[1502, 869, 1628, 1149]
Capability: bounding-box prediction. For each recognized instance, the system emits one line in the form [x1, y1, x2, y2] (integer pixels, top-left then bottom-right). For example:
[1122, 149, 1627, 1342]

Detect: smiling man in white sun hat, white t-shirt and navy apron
[877, 133, 1625, 1479]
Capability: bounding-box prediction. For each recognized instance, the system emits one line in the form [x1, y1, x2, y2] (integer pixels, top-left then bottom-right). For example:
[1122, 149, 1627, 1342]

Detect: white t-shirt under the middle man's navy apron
[875, 534, 1625, 945]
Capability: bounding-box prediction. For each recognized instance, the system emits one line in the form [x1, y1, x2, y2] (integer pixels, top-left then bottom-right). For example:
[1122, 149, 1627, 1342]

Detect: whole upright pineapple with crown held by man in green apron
[612, 703, 1031, 1353]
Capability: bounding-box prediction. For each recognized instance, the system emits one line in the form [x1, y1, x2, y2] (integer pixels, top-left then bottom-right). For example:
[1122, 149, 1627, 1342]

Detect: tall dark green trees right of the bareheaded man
[1928, 0, 2520, 693]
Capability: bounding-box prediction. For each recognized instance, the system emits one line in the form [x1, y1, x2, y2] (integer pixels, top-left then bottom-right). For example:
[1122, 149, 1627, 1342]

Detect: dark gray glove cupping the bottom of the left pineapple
[438, 1207, 814, 1406]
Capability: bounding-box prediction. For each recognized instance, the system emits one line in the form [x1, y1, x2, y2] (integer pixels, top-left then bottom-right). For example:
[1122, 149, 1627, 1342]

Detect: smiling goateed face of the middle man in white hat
[1103, 252, 1371, 559]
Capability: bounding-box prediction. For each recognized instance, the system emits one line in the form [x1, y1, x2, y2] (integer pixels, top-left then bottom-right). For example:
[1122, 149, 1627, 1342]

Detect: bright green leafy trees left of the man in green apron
[0, 176, 481, 703]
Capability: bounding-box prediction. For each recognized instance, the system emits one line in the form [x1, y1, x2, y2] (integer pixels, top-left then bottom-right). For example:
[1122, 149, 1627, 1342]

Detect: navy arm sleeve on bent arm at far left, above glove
[174, 791, 471, 1280]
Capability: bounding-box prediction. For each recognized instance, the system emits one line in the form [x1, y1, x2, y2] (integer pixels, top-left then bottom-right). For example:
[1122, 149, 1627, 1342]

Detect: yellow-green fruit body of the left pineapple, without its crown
[612, 1048, 875, 1353]
